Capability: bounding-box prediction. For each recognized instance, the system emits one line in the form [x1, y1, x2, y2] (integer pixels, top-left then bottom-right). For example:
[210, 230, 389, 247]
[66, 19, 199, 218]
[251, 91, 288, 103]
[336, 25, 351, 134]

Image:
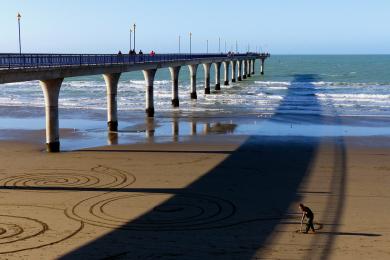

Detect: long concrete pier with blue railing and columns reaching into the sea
[0, 53, 270, 152]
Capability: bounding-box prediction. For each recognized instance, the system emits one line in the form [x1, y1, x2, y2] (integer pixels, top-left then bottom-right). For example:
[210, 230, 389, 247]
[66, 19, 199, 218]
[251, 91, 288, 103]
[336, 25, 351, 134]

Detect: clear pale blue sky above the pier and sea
[0, 0, 390, 54]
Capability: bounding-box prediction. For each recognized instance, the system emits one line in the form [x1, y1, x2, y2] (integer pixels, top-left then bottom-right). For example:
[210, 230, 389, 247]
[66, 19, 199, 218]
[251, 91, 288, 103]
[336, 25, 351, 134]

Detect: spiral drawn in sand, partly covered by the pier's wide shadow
[68, 193, 235, 231]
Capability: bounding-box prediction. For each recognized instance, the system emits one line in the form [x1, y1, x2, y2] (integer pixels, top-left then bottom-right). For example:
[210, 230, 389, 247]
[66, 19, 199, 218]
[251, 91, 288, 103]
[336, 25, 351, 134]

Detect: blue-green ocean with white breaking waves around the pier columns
[0, 55, 390, 149]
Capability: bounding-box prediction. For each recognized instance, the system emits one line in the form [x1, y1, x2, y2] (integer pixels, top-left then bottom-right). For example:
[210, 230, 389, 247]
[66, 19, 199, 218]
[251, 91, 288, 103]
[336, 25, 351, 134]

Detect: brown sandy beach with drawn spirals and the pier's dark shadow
[0, 135, 390, 259]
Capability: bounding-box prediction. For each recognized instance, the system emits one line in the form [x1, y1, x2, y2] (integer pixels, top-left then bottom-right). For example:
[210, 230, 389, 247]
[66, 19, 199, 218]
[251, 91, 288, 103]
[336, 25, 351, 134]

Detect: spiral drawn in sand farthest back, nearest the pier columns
[0, 165, 135, 192]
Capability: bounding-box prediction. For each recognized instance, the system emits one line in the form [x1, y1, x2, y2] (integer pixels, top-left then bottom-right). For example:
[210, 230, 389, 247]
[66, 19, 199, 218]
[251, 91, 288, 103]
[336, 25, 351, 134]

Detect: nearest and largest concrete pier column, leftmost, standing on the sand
[39, 78, 64, 152]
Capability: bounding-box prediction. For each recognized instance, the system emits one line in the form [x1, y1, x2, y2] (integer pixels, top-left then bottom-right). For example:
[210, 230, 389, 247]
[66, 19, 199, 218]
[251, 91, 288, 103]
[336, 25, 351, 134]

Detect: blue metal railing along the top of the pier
[0, 53, 269, 69]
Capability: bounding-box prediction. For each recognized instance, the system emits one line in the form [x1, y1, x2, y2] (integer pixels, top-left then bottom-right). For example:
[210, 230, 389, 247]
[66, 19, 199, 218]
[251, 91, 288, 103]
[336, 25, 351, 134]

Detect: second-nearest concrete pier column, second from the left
[103, 73, 121, 132]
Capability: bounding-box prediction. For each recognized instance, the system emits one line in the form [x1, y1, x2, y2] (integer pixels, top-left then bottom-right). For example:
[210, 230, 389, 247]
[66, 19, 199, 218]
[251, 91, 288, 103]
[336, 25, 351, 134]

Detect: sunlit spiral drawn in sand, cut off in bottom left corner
[0, 205, 83, 254]
